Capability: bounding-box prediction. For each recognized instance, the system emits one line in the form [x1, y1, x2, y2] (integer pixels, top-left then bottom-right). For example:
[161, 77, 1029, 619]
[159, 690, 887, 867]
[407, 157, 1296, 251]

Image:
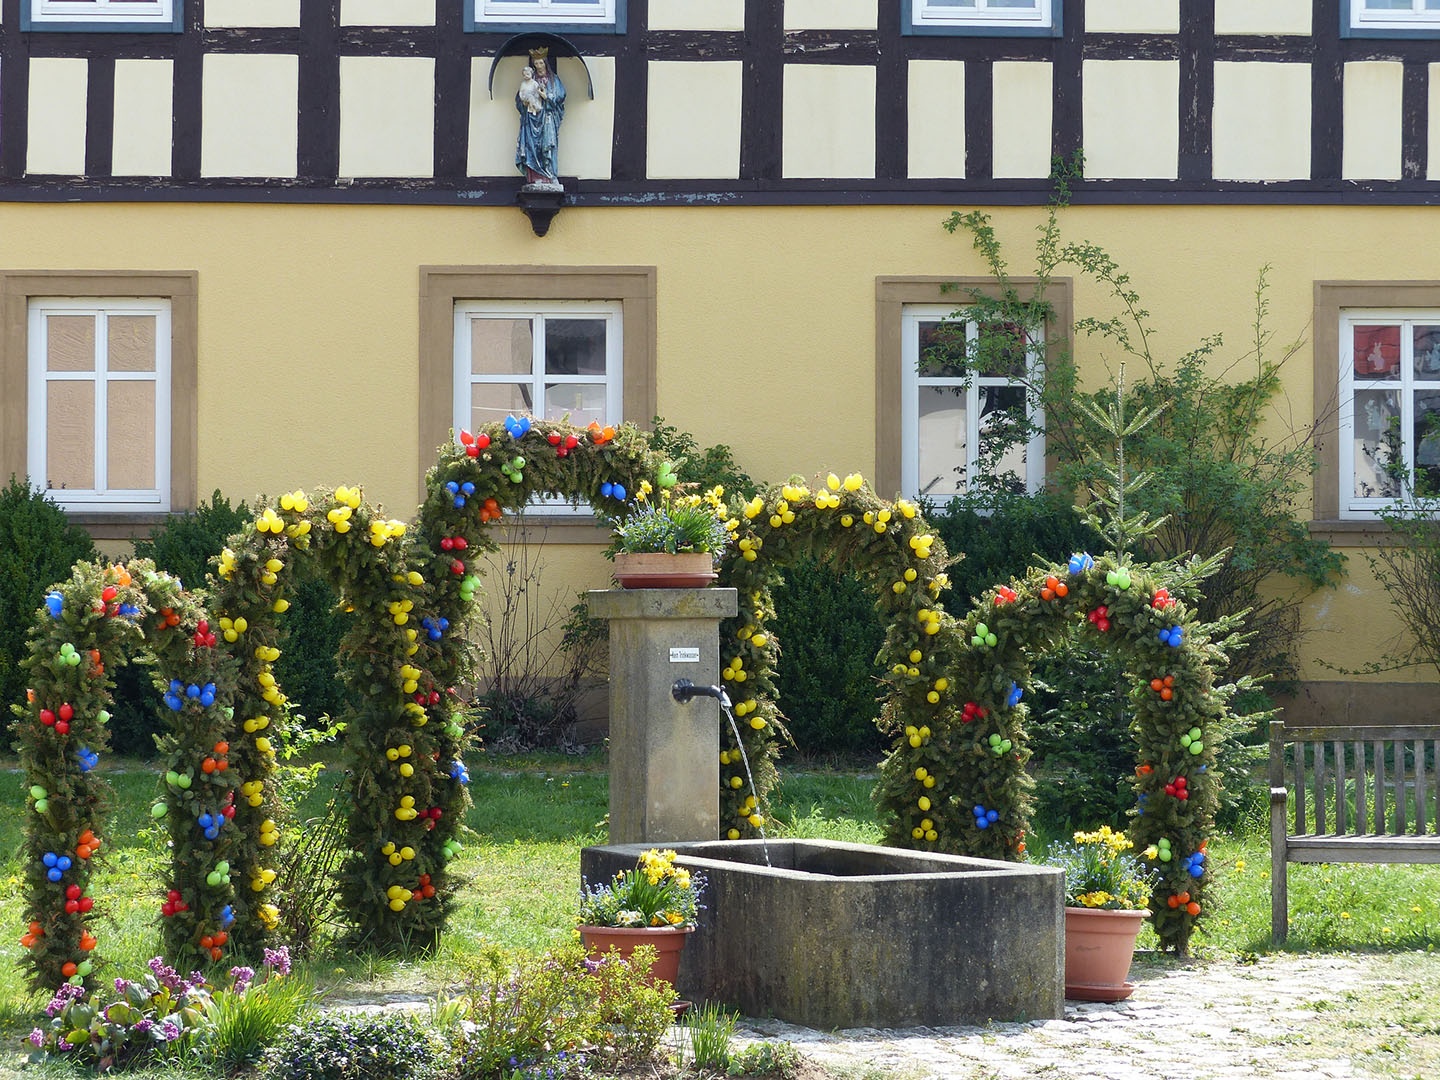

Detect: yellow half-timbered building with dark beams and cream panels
[0, 0, 1440, 713]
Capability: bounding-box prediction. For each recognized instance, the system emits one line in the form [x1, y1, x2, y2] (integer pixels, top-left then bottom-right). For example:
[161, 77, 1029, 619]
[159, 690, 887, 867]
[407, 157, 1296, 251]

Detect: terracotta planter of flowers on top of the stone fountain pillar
[606, 484, 737, 588]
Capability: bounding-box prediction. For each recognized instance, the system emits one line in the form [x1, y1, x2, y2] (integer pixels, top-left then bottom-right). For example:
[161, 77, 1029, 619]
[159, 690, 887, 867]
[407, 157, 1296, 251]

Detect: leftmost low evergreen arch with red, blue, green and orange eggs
[14, 560, 244, 988]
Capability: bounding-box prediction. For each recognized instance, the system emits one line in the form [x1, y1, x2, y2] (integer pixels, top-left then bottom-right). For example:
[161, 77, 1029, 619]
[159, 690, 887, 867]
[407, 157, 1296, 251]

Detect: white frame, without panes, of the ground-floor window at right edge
[1338, 308, 1440, 520]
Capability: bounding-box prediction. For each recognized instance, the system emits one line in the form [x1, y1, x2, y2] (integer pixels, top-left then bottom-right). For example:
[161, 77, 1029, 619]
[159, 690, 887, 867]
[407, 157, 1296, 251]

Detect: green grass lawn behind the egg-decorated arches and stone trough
[0, 757, 1440, 1074]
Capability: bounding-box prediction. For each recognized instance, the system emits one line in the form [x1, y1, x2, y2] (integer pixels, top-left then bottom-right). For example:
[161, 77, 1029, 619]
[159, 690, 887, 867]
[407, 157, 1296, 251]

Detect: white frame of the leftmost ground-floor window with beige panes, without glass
[26, 297, 171, 514]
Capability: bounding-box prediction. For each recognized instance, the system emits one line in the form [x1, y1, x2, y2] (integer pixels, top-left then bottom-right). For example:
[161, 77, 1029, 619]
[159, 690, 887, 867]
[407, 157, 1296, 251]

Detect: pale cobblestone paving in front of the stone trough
[739, 955, 1440, 1080]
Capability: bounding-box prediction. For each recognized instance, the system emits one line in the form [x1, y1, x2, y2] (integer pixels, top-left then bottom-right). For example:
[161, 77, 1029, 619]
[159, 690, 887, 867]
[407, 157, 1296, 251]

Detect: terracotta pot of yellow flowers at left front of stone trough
[579, 848, 706, 985]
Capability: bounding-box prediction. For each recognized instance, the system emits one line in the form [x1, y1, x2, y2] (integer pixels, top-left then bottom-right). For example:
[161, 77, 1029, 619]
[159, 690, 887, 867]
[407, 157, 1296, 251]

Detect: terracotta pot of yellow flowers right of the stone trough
[1045, 825, 1155, 1001]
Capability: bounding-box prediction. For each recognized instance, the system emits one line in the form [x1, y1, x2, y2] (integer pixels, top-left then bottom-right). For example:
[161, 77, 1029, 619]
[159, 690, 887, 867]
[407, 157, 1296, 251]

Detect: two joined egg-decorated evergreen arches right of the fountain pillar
[720, 475, 1233, 953]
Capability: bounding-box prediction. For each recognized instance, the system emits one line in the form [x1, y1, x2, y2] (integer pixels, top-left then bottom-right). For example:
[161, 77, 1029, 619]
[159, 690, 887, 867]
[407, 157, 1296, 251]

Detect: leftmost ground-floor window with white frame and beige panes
[26, 298, 171, 513]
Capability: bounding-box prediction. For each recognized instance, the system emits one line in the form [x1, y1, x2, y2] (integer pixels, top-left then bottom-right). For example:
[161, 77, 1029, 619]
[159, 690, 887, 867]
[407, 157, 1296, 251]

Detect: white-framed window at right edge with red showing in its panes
[1339, 310, 1440, 517]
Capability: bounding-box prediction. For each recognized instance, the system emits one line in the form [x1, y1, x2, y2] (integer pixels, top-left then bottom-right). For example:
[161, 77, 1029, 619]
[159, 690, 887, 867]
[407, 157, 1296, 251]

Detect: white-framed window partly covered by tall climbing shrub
[900, 304, 1045, 503]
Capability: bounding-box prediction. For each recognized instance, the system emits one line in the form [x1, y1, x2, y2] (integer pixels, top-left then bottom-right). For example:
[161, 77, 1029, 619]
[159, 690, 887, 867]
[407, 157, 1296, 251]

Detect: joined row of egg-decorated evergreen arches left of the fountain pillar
[16, 418, 658, 986]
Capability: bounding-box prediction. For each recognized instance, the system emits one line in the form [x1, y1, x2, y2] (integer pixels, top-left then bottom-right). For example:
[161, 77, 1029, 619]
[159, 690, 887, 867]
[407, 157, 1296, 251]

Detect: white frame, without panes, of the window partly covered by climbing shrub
[900, 304, 1045, 503]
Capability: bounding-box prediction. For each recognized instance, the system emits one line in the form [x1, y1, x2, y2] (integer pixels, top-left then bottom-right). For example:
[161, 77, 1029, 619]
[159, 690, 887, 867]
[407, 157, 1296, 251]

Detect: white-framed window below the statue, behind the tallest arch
[454, 301, 625, 432]
